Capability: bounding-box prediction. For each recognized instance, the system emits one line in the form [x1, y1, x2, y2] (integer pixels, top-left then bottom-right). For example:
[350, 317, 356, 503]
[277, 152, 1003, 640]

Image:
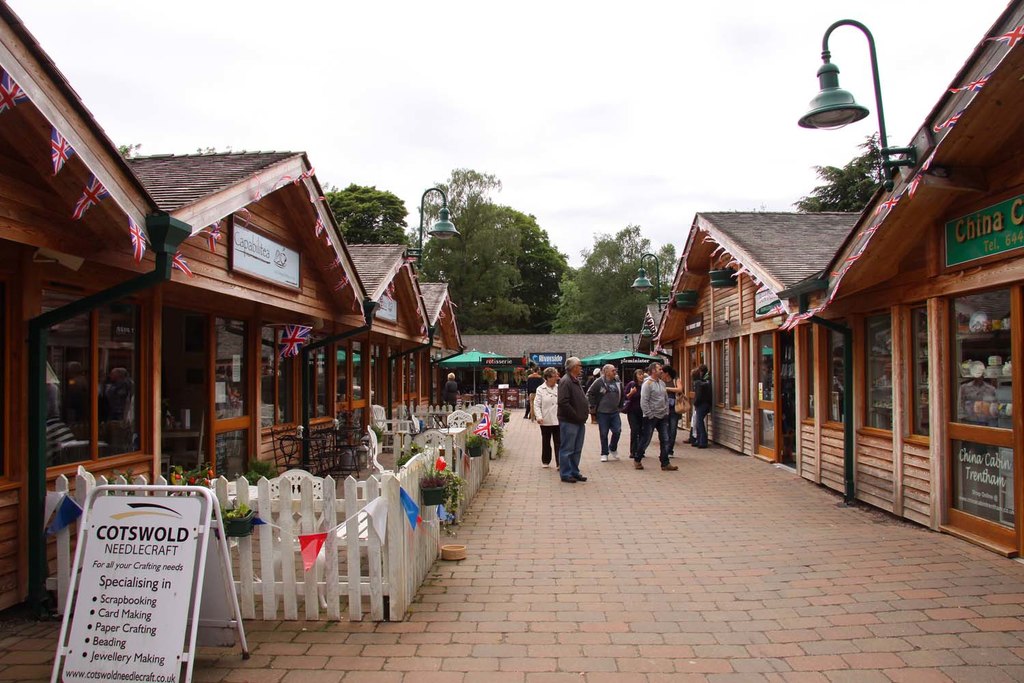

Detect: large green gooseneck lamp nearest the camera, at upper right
[798, 19, 918, 189]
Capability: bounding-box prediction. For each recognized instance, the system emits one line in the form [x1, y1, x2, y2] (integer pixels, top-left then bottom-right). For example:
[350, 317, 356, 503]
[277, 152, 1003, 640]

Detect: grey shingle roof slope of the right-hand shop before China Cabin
[697, 212, 860, 287]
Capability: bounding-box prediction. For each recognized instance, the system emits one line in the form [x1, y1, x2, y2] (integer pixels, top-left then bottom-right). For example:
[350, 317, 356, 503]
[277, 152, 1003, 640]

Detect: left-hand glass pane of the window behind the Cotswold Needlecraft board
[42, 291, 93, 465]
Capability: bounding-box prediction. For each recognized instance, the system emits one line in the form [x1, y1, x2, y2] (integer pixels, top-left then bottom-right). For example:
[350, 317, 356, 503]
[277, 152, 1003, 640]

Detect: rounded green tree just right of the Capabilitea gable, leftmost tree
[324, 183, 409, 245]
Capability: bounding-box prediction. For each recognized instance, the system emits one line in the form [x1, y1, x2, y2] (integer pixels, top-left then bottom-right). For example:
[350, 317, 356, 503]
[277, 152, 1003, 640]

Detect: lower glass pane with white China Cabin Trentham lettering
[952, 441, 1016, 527]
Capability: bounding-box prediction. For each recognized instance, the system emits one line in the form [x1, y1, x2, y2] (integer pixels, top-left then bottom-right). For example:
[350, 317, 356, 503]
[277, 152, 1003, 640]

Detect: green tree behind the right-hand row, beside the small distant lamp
[553, 225, 676, 334]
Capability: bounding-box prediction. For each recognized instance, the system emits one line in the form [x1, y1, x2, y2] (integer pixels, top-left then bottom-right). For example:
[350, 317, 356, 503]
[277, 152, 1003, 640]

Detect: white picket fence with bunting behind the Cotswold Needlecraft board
[47, 438, 489, 621]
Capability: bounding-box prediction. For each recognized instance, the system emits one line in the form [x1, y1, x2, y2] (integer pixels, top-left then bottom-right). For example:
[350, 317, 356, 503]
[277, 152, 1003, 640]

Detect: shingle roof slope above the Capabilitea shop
[128, 152, 302, 211]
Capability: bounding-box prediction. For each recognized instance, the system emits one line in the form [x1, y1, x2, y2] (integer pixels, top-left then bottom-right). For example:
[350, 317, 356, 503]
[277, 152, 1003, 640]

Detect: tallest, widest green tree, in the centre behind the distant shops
[422, 169, 567, 334]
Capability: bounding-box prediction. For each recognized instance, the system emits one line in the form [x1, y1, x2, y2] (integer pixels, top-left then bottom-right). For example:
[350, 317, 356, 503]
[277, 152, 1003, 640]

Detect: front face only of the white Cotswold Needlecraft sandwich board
[62, 496, 203, 681]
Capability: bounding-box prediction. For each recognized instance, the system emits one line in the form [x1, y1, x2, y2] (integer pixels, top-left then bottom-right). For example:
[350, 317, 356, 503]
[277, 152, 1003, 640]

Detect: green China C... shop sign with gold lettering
[945, 195, 1024, 267]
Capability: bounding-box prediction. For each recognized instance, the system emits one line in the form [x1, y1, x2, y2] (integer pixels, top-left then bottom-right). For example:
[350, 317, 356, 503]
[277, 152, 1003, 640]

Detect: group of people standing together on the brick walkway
[526, 356, 713, 483]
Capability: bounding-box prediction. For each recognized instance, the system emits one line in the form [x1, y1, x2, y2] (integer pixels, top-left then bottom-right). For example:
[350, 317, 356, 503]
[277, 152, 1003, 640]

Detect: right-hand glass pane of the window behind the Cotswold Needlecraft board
[98, 303, 141, 457]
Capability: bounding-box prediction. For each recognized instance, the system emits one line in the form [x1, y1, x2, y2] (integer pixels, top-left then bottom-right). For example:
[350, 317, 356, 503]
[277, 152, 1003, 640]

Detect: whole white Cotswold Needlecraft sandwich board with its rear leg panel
[50, 485, 249, 683]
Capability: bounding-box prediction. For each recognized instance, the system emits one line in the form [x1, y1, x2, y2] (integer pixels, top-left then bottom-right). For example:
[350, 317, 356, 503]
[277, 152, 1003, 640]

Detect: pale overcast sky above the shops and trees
[9, 0, 1007, 265]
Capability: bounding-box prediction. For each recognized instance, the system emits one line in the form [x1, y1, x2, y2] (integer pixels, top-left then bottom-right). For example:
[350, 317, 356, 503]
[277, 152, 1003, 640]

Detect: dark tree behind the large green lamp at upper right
[794, 134, 882, 213]
